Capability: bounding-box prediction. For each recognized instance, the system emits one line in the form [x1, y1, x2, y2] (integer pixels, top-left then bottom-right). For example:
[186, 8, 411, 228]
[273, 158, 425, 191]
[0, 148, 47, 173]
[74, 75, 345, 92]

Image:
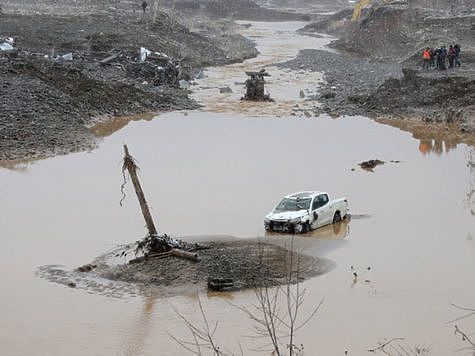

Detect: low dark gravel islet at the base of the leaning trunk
[38, 240, 327, 294]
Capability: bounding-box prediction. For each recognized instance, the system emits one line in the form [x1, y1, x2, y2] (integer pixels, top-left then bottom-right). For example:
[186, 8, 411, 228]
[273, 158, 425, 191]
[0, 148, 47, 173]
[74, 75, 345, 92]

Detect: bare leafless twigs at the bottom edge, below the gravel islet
[170, 238, 323, 356]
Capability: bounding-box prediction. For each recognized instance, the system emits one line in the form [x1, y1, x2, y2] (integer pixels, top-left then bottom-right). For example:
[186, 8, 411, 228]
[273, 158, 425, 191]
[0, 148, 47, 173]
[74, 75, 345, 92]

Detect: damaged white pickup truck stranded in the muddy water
[264, 192, 348, 234]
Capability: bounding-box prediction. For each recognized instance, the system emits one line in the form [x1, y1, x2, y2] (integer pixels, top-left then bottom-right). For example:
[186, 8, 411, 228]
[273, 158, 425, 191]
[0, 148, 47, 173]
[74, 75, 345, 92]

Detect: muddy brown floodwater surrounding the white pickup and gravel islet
[0, 23, 475, 355]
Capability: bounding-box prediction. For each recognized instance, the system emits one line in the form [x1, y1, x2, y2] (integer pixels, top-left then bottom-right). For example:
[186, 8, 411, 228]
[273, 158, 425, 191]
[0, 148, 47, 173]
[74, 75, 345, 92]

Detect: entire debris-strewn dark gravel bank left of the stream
[0, 0, 257, 160]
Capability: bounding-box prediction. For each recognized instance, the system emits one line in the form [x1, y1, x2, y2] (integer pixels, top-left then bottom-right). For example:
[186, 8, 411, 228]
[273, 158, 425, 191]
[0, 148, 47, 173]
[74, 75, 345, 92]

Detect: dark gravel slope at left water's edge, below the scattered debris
[0, 51, 196, 160]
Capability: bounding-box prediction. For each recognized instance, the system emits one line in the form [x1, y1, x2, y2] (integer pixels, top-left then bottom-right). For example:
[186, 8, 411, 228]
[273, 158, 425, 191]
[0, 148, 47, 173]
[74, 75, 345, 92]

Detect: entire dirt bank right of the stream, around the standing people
[301, 1, 475, 132]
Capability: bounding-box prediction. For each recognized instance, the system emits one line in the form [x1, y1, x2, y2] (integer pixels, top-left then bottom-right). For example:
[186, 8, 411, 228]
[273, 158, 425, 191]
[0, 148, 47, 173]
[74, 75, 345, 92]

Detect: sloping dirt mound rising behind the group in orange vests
[332, 4, 475, 62]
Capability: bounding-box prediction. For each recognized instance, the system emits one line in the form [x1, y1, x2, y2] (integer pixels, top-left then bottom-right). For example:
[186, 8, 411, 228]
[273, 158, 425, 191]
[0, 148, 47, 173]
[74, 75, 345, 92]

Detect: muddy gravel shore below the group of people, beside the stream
[279, 50, 475, 140]
